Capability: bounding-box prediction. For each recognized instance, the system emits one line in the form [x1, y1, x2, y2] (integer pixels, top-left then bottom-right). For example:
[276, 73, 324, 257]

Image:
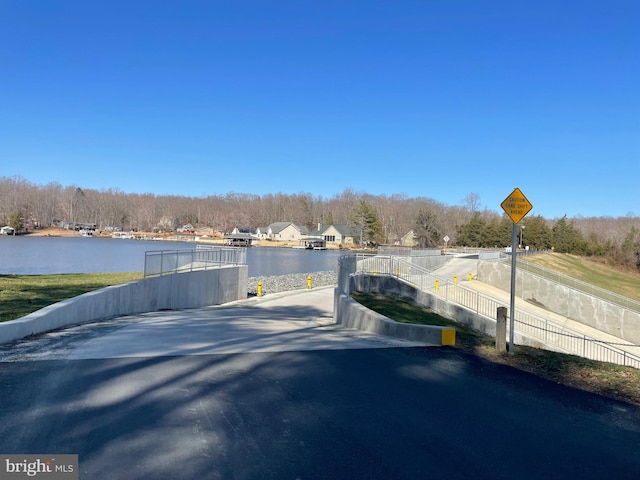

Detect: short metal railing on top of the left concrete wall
[144, 245, 247, 277]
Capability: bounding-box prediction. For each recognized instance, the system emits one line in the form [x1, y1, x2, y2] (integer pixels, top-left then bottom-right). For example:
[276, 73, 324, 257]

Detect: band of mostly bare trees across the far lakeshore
[0, 177, 640, 267]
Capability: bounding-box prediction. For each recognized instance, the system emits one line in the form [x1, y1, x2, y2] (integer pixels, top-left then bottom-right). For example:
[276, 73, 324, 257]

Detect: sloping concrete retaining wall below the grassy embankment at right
[478, 262, 640, 344]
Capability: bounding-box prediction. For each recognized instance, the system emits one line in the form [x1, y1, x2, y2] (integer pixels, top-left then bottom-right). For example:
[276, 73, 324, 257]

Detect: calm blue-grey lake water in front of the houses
[0, 236, 345, 277]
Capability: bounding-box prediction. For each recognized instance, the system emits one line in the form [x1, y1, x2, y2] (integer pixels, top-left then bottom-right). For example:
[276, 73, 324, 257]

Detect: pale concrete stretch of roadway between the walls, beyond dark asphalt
[0, 287, 427, 361]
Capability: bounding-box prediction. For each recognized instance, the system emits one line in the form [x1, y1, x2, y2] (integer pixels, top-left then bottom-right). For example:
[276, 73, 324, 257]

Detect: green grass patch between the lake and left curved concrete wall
[0, 273, 143, 322]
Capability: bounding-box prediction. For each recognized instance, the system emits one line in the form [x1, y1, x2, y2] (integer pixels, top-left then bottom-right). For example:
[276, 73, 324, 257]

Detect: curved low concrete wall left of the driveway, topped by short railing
[0, 265, 248, 344]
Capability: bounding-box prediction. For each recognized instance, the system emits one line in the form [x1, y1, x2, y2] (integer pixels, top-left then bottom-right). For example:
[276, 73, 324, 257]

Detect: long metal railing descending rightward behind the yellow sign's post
[339, 254, 640, 369]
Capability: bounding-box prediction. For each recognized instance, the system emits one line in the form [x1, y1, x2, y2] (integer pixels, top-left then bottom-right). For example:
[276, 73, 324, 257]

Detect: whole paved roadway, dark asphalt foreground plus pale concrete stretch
[0, 290, 640, 480]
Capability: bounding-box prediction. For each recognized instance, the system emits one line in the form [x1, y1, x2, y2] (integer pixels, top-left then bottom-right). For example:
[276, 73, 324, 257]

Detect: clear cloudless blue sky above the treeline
[0, 0, 640, 219]
